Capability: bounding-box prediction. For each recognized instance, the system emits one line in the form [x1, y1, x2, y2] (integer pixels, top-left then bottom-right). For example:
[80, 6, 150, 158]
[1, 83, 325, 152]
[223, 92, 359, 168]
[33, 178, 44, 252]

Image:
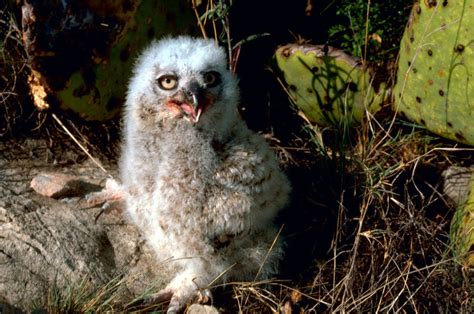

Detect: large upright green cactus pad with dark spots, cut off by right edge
[393, 0, 474, 145]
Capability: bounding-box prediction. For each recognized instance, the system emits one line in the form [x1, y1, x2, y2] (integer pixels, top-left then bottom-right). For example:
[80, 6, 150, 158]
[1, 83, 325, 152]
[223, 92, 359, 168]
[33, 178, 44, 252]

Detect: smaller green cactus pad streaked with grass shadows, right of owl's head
[275, 44, 385, 126]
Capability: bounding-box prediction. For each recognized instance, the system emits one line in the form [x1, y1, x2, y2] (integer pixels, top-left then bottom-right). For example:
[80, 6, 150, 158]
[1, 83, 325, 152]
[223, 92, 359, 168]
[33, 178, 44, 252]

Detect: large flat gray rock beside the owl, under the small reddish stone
[0, 141, 163, 311]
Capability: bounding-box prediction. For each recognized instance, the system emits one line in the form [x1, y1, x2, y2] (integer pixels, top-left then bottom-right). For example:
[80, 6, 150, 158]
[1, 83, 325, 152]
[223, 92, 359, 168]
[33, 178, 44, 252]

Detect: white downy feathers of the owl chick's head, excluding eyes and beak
[125, 36, 239, 136]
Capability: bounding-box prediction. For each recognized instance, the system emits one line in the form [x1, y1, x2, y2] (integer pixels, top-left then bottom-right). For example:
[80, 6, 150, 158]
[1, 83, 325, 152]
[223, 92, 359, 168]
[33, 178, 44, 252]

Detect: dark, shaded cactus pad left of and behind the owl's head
[22, 0, 195, 120]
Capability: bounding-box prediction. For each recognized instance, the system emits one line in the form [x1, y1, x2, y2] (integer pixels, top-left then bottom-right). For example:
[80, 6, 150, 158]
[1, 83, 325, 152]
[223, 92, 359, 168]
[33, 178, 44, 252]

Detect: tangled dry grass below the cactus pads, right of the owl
[212, 119, 473, 313]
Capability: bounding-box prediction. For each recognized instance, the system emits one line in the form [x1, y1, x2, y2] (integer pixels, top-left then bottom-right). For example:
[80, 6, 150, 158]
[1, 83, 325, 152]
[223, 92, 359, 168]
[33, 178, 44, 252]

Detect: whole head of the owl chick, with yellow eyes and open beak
[126, 37, 239, 131]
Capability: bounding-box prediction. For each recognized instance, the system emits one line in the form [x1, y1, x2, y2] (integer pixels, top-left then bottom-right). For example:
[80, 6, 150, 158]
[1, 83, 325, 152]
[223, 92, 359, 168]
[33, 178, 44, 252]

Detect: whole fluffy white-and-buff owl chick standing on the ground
[121, 37, 290, 313]
